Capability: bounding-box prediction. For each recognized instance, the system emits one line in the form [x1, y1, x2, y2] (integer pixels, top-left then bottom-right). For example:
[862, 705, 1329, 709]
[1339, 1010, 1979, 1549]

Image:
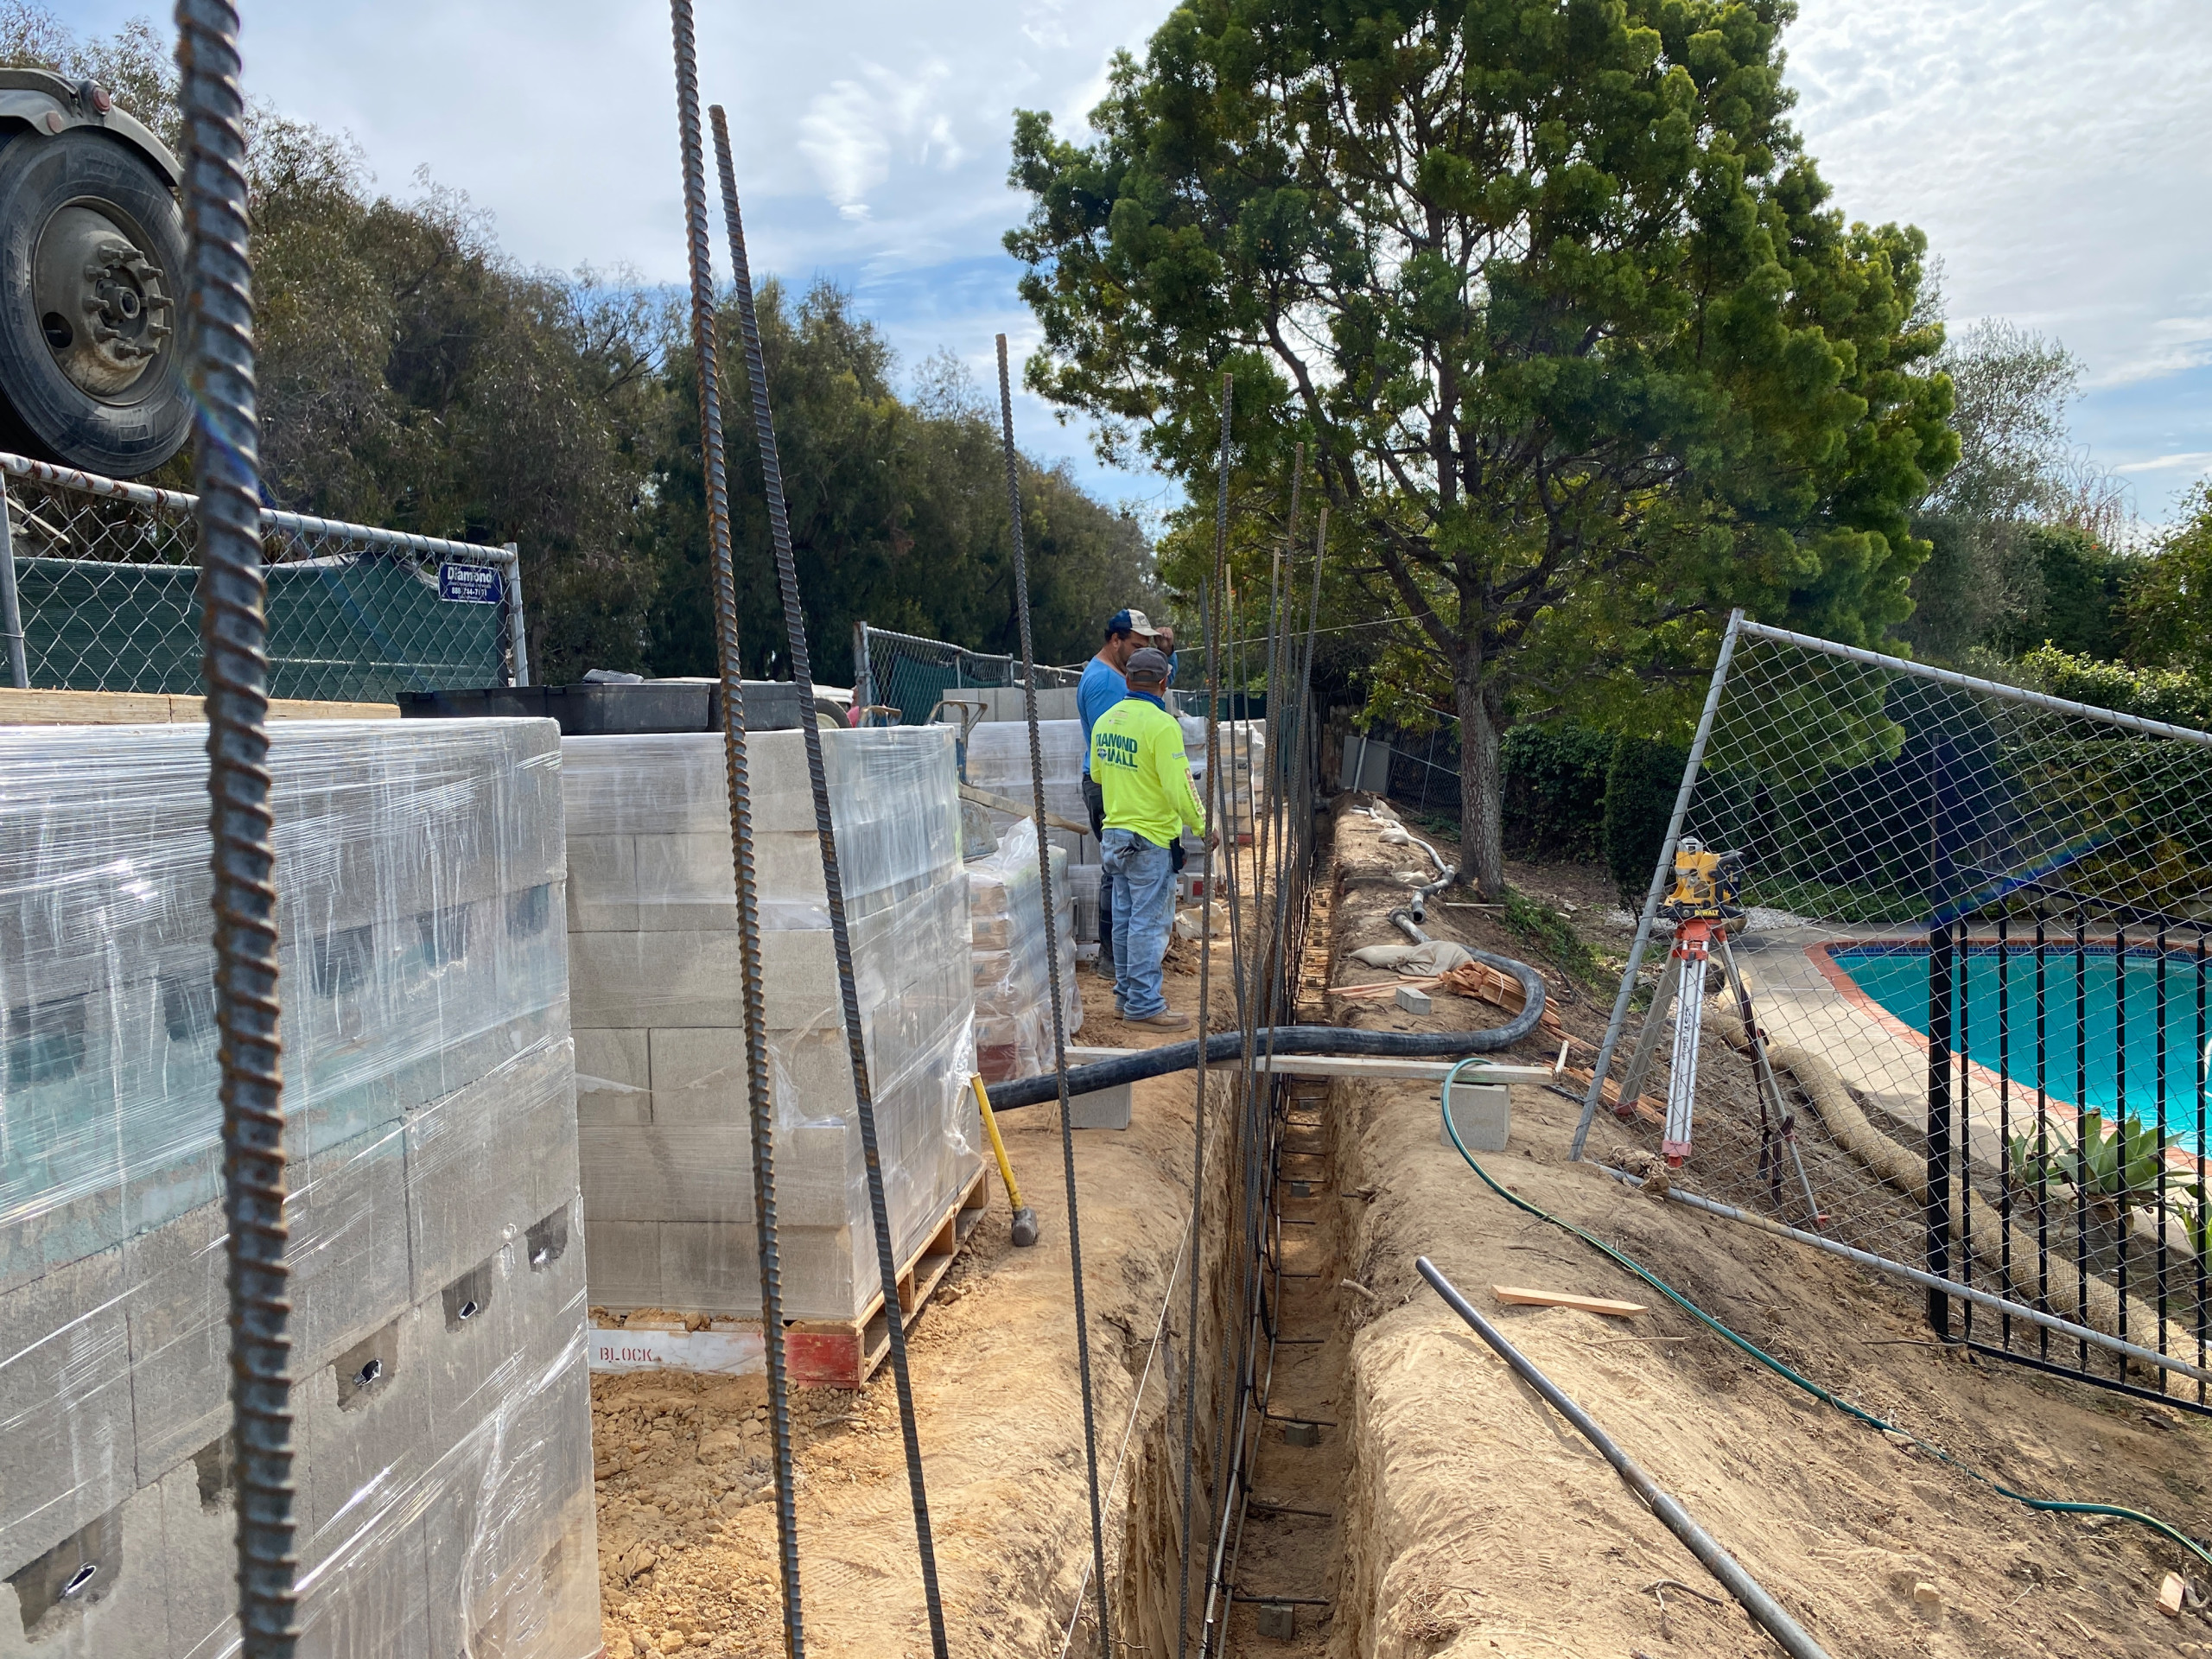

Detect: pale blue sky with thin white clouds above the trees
[78, 0, 2212, 524]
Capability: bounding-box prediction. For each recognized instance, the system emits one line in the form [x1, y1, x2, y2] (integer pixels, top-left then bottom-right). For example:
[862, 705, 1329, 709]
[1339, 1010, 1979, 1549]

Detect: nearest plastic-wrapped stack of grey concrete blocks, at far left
[0, 721, 600, 1659]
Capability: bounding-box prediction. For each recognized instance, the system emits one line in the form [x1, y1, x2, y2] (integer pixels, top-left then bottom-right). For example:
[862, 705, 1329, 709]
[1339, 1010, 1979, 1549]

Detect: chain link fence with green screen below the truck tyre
[0, 454, 529, 702]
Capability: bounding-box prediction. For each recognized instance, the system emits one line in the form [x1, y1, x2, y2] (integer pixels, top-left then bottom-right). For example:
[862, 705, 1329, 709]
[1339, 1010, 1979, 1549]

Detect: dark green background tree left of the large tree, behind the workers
[639, 281, 1157, 679]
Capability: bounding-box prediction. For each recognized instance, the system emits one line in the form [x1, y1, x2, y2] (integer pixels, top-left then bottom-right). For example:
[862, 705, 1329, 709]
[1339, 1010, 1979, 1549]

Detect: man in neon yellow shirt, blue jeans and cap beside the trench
[1090, 646, 1214, 1031]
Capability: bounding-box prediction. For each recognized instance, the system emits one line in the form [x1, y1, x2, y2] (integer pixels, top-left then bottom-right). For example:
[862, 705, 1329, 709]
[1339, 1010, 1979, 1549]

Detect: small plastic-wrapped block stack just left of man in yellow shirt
[967, 818, 1084, 1084]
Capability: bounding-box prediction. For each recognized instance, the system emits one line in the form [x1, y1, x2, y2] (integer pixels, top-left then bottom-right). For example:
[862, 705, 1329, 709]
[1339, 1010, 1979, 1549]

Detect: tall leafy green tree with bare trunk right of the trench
[1007, 0, 1955, 893]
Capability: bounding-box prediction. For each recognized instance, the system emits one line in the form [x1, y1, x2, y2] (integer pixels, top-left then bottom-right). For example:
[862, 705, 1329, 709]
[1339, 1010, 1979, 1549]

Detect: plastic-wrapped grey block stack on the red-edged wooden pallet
[562, 726, 982, 1320]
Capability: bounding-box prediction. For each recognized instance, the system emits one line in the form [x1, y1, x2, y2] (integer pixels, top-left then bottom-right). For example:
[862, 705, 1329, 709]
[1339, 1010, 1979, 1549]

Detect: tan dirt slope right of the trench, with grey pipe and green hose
[1330, 800, 2212, 1659]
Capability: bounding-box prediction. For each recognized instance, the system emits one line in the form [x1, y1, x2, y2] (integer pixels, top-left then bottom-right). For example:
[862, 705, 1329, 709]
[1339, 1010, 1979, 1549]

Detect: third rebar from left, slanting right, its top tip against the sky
[716, 107, 947, 1659]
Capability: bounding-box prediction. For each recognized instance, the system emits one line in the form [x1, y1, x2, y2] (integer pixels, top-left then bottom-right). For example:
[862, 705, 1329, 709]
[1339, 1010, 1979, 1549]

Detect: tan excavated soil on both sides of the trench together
[593, 800, 2212, 1659]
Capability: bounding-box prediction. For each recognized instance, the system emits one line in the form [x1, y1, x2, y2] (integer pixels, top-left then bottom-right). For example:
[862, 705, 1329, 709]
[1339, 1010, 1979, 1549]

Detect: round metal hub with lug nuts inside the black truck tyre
[31, 204, 175, 400]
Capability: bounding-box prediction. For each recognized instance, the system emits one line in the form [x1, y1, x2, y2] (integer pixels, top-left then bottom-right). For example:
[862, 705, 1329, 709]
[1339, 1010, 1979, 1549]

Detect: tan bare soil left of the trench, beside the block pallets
[593, 925, 1234, 1659]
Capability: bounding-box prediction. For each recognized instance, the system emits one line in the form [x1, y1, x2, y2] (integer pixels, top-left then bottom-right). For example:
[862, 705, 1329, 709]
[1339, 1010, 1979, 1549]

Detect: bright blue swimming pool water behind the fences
[1834, 943, 2212, 1148]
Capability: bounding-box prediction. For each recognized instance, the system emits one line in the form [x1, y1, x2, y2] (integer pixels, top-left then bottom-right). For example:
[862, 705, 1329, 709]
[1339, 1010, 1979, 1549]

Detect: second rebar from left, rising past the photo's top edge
[671, 52, 805, 1659]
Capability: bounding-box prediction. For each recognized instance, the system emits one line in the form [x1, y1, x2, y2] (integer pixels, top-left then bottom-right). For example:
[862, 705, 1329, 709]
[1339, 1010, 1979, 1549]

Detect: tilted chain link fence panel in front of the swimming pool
[1586, 621, 2212, 1405]
